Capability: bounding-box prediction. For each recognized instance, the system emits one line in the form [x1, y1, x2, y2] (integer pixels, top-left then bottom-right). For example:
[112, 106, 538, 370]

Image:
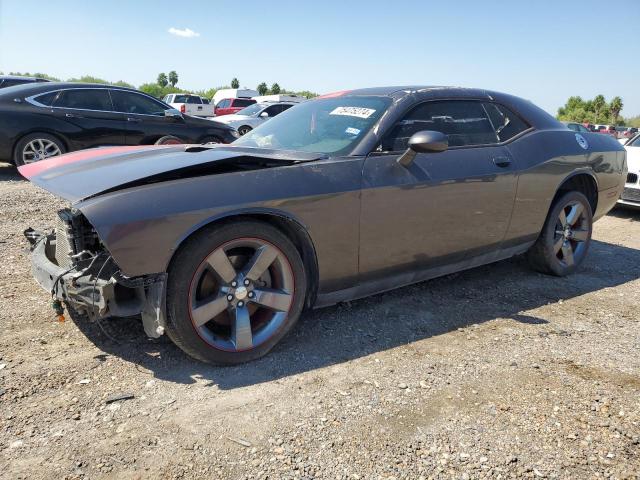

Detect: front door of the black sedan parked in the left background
[111, 89, 188, 145]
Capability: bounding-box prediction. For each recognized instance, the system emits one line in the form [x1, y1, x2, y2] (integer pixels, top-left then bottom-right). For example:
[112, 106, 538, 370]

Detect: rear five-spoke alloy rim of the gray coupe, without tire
[553, 201, 590, 267]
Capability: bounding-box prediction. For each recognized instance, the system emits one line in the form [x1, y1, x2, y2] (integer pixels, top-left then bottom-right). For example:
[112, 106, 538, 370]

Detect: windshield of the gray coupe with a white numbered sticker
[233, 96, 391, 155]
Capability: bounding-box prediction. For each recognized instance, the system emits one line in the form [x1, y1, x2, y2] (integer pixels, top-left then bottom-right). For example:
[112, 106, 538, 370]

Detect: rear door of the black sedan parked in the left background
[51, 88, 126, 146]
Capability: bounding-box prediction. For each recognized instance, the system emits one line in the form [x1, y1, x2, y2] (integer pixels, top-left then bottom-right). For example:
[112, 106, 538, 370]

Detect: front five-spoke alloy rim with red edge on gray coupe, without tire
[189, 238, 295, 351]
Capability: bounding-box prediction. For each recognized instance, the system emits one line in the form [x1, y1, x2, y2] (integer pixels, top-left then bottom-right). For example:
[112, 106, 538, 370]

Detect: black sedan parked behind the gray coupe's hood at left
[0, 82, 237, 165]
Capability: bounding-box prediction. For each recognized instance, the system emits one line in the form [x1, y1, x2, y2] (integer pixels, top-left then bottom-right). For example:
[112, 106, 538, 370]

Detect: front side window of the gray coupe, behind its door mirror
[382, 100, 498, 151]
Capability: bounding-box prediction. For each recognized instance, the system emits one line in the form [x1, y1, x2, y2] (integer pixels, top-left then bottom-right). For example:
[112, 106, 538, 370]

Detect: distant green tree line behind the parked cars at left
[0, 70, 318, 99]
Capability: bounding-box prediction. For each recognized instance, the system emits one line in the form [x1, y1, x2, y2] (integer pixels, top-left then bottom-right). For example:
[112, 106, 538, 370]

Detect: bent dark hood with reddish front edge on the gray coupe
[18, 145, 326, 203]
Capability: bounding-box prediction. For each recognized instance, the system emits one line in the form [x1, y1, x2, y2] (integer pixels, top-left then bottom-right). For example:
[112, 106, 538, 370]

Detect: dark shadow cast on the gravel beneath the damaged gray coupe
[66, 237, 640, 389]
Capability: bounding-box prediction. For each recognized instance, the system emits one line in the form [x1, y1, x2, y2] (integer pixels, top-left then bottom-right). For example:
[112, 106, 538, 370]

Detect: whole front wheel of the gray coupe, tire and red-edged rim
[167, 221, 307, 364]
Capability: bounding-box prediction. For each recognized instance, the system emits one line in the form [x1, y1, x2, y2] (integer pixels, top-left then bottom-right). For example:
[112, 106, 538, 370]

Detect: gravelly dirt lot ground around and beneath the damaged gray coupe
[0, 165, 640, 479]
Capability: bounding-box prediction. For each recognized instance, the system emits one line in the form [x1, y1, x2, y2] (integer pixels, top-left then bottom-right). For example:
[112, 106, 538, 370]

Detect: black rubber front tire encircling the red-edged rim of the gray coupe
[166, 221, 307, 364]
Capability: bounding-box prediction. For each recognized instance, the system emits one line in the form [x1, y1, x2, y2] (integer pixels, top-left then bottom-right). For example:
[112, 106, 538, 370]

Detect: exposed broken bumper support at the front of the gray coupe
[25, 229, 167, 338]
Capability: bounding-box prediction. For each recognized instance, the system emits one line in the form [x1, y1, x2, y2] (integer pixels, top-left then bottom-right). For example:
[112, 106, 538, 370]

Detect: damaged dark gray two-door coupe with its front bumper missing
[20, 87, 627, 363]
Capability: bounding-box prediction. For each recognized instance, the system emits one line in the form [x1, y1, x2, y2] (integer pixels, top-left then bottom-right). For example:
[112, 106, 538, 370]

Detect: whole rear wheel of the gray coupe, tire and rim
[527, 192, 593, 277]
